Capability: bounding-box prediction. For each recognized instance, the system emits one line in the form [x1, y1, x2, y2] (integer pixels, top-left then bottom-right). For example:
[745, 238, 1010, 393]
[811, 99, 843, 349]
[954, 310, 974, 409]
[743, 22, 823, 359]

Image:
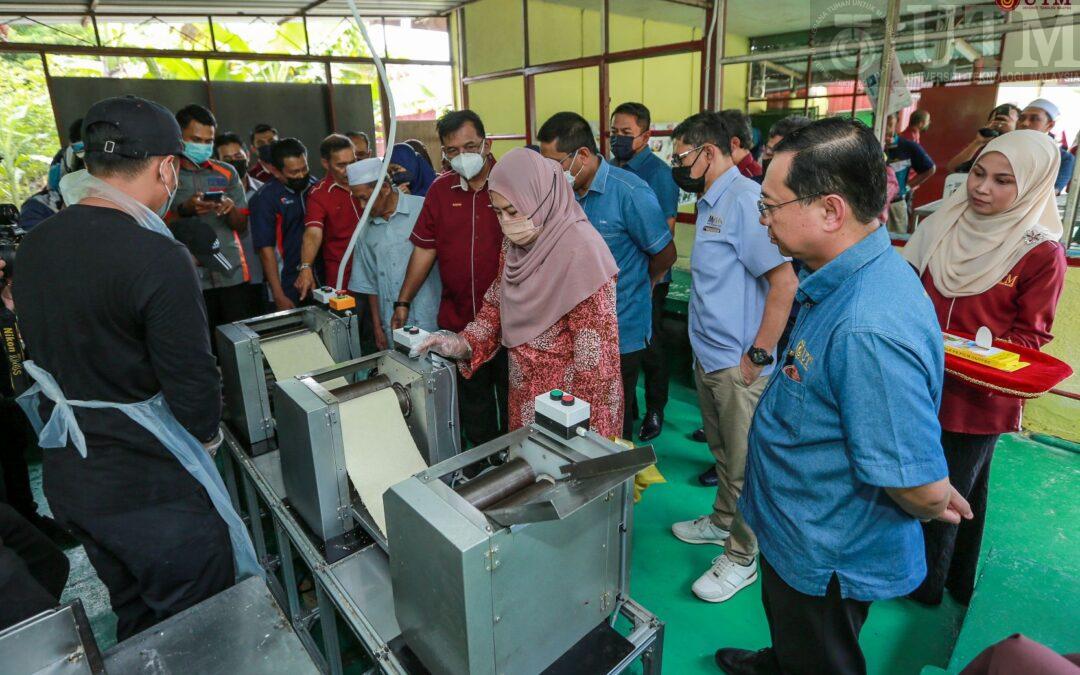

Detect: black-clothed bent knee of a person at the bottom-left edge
[0, 504, 70, 630]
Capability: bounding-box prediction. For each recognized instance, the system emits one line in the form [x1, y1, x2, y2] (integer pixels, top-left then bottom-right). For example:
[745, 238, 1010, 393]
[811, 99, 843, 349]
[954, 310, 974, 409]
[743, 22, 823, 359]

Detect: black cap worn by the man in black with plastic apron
[82, 96, 184, 159]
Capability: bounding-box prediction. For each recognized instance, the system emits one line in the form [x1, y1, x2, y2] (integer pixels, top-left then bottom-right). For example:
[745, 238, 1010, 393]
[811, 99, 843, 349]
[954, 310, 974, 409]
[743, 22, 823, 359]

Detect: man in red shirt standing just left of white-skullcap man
[296, 134, 360, 300]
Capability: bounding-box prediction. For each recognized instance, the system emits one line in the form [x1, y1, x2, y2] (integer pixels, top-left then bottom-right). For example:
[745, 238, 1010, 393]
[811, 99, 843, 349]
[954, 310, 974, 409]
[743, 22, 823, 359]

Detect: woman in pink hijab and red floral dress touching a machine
[417, 148, 623, 436]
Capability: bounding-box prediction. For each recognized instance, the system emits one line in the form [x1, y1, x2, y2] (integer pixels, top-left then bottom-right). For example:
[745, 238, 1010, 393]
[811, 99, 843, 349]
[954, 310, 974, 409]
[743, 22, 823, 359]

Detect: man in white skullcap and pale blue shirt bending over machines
[346, 158, 443, 349]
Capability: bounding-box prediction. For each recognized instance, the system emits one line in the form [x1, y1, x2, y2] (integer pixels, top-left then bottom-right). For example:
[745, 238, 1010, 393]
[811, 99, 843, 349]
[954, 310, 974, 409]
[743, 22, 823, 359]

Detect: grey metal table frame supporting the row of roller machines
[220, 428, 664, 675]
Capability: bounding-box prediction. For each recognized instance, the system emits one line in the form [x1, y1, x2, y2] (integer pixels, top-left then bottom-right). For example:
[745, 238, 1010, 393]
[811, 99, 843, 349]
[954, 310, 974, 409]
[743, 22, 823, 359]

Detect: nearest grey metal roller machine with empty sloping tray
[384, 423, 656, 675]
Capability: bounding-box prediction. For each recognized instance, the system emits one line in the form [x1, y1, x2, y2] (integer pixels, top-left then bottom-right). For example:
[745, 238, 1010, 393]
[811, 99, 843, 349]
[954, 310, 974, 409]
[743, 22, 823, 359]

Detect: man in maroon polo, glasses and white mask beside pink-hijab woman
[392, 110, 509, 446]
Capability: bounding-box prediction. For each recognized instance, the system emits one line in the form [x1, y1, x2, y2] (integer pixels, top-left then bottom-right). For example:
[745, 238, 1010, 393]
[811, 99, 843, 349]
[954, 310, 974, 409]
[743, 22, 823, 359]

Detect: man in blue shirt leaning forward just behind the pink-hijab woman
[537, 112, 675, 440]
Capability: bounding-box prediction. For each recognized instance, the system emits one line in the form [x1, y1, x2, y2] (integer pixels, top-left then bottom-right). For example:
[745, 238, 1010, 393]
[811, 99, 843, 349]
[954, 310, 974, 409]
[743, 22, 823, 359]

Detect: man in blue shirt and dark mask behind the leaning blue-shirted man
[611, 103, 678, 442]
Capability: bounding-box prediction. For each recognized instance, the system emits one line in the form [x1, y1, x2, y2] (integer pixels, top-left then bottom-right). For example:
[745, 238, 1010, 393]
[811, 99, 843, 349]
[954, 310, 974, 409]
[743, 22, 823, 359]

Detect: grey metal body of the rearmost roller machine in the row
[216, 307, 360, 455]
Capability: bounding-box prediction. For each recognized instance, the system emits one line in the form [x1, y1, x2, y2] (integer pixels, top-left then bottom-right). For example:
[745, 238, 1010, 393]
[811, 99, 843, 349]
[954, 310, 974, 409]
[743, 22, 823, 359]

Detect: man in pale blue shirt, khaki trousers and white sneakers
[672, 112, 798, 603]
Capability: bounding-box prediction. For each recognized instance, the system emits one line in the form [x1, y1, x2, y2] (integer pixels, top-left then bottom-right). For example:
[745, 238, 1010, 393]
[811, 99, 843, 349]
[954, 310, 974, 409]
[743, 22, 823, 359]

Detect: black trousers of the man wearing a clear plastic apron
[53, 486, 235, 640]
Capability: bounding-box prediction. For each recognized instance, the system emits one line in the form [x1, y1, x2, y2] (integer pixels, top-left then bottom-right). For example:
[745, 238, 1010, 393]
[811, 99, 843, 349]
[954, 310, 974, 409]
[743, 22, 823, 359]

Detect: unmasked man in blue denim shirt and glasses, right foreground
[716, 118, 971, 674]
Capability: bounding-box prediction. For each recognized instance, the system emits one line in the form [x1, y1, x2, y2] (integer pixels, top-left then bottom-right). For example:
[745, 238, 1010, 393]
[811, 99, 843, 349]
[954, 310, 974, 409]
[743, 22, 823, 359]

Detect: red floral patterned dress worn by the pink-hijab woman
[458, 264, 623, 437]
